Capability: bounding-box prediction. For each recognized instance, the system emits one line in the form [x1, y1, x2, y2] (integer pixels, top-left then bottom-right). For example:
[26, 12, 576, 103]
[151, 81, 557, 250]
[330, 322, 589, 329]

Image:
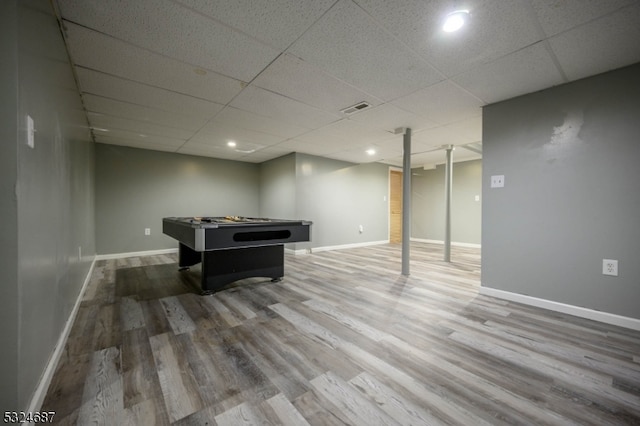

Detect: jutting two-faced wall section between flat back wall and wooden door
[260, 153, 389, 250]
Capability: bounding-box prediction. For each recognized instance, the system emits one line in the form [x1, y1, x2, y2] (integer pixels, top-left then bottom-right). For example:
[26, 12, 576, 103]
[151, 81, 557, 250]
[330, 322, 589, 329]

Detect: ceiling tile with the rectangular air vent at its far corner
[252, 54, 380, 114]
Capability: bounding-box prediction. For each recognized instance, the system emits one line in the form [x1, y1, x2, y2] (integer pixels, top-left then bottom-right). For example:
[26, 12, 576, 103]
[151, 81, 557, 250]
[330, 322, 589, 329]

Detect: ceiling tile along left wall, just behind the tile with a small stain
[76, 68, 222, 118]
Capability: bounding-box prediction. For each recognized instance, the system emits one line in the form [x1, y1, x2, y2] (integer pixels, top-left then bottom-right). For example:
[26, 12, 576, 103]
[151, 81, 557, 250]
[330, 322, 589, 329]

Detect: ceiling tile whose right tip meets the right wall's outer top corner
[393, 81, 484, 124]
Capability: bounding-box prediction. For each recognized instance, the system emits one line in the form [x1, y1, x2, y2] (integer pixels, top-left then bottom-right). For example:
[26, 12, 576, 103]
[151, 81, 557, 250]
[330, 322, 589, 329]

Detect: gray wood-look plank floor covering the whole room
[42, 243, 640, 426]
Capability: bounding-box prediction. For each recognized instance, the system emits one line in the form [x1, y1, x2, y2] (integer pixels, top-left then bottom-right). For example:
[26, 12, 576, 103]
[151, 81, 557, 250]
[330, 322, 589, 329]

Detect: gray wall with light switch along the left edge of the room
[0, 0, 95, 412]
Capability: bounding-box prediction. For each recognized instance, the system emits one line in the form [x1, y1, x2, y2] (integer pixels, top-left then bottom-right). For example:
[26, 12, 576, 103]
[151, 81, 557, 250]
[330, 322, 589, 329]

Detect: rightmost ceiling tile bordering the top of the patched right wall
[549, 2, 640, 80]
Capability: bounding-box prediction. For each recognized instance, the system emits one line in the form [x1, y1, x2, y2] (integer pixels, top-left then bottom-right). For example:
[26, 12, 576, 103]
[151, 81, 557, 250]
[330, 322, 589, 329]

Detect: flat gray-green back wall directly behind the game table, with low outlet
[96, 144, 260, 254]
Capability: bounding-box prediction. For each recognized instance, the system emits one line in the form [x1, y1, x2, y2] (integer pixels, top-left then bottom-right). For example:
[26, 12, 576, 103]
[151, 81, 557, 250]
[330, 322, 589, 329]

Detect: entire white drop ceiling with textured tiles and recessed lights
[55, 0, 640, 166]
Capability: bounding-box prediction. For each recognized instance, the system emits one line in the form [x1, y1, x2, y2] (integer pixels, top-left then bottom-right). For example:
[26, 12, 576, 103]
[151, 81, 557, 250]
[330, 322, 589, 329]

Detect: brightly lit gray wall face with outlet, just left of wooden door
[296, 154, 389, 248]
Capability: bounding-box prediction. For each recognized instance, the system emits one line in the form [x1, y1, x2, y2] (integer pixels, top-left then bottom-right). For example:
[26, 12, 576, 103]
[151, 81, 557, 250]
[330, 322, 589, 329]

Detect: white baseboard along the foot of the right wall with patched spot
[480, 287, 640, 331]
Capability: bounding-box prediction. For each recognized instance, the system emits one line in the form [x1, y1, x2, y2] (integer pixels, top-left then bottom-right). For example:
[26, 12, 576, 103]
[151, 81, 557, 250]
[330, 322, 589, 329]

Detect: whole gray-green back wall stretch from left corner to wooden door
[96, 150, 388, 254]
